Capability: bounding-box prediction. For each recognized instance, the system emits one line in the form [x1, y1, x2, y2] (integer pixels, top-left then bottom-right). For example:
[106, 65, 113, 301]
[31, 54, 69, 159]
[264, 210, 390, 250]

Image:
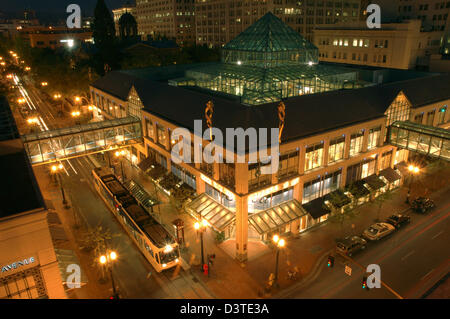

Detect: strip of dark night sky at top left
[0, 0, 127, 18]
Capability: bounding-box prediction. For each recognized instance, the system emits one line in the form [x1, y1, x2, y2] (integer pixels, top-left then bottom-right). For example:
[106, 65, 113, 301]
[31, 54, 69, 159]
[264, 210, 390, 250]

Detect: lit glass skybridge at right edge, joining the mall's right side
[389, 121, 450, 161]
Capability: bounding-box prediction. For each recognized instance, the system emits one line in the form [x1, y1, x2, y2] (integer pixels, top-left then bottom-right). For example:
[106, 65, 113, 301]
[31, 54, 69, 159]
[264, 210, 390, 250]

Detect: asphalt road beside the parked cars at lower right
[286, 193, 450, 299]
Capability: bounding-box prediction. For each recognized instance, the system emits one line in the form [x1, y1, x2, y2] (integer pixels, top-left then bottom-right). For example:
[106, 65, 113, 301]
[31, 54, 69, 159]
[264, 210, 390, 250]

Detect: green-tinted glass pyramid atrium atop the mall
[170, 12, 360, 105]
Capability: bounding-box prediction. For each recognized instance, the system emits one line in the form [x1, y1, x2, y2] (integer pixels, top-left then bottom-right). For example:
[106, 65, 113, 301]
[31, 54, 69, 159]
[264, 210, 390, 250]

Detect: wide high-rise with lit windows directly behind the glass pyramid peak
[195, 0, 361, 47]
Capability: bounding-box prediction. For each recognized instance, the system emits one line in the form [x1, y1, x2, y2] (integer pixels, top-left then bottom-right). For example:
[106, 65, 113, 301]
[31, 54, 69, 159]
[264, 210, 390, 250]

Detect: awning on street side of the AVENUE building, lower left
[55, 249, 88, 290]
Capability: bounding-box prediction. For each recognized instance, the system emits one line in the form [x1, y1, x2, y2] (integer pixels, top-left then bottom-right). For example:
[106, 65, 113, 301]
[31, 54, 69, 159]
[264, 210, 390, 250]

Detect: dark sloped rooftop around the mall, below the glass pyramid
[92, 71, 450, 148]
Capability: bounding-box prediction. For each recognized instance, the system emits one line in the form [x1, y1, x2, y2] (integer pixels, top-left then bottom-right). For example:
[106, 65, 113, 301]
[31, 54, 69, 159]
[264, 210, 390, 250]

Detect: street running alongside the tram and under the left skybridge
[16, 75, 212, 298]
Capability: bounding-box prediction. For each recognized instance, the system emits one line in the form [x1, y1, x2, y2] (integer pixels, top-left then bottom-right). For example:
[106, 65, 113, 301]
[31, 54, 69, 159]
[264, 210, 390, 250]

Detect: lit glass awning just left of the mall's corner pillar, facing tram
[186, 193, 236, 231]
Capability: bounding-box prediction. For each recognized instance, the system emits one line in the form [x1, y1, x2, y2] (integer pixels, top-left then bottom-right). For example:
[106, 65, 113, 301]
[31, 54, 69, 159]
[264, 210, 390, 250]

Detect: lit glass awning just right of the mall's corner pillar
[248, 199, 306, 235]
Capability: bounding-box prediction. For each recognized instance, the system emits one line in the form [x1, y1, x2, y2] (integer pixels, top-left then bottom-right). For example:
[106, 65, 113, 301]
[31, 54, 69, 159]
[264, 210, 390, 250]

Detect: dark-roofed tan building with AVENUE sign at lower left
[0, 96, 67, 299]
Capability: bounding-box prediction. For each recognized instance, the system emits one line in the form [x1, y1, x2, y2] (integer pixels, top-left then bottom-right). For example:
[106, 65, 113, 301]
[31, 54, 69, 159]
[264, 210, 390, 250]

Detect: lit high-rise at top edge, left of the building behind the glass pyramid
[136, 0, 195, 45]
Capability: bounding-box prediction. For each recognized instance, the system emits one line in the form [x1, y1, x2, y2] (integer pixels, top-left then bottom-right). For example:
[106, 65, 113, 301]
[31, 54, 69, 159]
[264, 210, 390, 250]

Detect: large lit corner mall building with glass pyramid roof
[91, 13, 450, 260]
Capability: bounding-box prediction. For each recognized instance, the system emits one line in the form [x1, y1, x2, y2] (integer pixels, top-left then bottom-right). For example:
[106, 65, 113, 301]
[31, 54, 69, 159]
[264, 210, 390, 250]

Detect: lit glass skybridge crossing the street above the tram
[21, 116, 142, 165]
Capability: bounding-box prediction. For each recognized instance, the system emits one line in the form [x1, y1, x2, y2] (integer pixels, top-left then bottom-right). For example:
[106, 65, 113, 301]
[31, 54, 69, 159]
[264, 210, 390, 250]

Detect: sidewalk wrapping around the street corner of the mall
[95, 156, 450, 299]
